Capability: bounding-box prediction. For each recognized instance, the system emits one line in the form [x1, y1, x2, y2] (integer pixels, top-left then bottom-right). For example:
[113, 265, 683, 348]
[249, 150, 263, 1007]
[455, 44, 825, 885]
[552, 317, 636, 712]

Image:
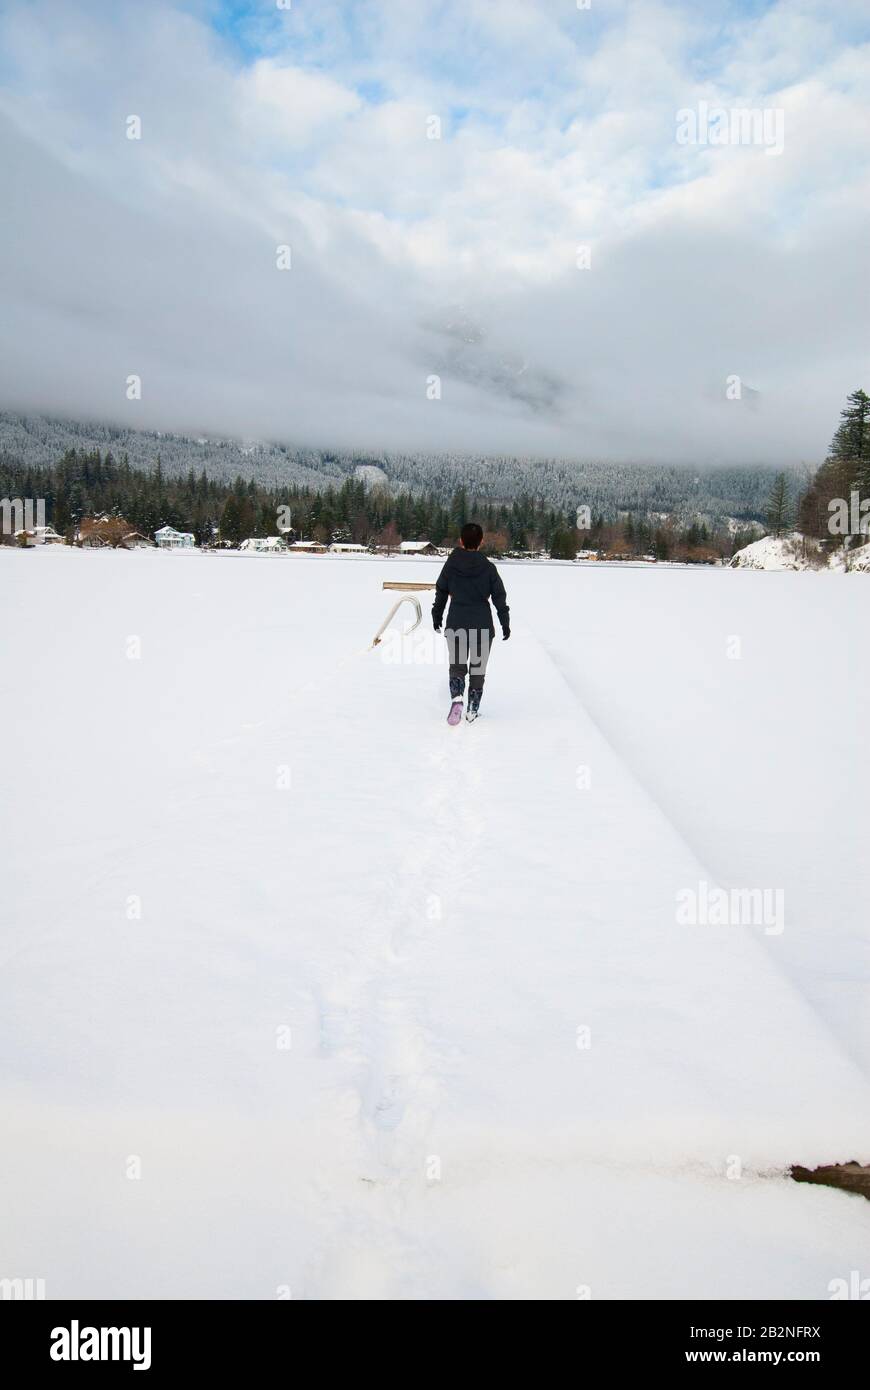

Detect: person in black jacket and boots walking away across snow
[432, 521, 510, 724]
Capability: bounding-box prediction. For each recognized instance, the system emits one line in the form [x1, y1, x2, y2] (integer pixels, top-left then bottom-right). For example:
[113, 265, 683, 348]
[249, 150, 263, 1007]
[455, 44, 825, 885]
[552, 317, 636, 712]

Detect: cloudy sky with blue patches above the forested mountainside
[0, 0, 870, 463]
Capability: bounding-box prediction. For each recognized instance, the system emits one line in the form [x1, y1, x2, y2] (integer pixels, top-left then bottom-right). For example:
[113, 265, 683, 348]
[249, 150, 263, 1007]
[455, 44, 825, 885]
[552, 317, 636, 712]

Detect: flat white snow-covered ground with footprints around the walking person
[0, 549, 870, 1298]
